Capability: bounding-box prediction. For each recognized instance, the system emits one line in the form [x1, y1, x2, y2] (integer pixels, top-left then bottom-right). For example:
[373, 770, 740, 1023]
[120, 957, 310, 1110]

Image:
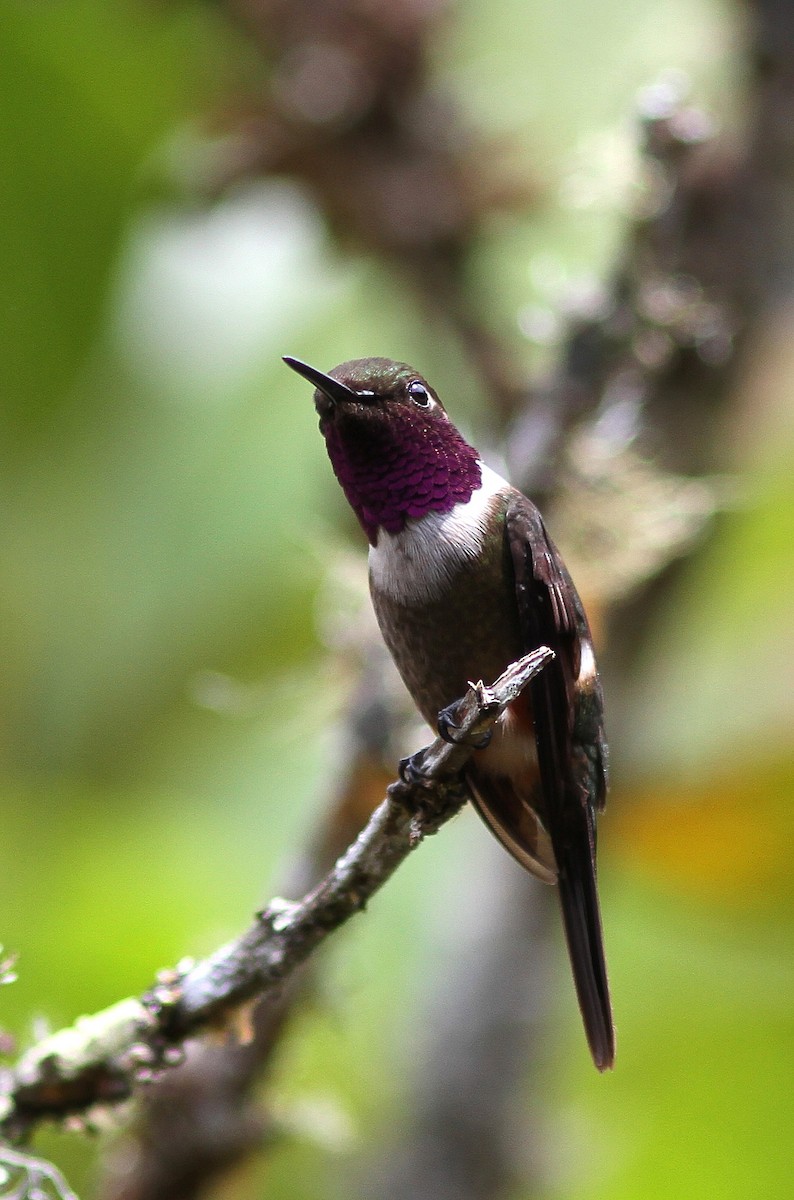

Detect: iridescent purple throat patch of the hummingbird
[323, 409, 482, 546]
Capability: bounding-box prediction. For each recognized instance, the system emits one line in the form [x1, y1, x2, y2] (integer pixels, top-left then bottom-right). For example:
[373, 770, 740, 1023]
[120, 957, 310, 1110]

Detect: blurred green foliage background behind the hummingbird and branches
[0, 0, 794, 1200]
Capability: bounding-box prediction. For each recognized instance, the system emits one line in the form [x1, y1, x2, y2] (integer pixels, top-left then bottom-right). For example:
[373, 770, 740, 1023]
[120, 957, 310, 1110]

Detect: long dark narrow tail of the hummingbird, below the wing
[555, 811, 615, 1070]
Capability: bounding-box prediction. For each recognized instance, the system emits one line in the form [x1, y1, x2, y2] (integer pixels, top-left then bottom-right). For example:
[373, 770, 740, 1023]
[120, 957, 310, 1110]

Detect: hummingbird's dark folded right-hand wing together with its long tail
[505, 493, 614, 1070]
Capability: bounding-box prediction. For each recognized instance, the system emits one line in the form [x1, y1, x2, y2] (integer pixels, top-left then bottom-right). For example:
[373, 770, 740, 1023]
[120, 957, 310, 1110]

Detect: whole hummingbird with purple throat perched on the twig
[284, 356, 615, 1070]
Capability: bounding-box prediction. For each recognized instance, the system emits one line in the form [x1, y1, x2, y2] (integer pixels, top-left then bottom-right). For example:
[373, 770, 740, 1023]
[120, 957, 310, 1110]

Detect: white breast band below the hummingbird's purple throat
[369, 463, 510, 605]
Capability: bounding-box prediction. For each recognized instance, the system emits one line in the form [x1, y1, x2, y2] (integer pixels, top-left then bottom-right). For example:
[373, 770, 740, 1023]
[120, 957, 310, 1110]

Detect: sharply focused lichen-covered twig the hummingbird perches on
[0, 647, 552, 1140]
